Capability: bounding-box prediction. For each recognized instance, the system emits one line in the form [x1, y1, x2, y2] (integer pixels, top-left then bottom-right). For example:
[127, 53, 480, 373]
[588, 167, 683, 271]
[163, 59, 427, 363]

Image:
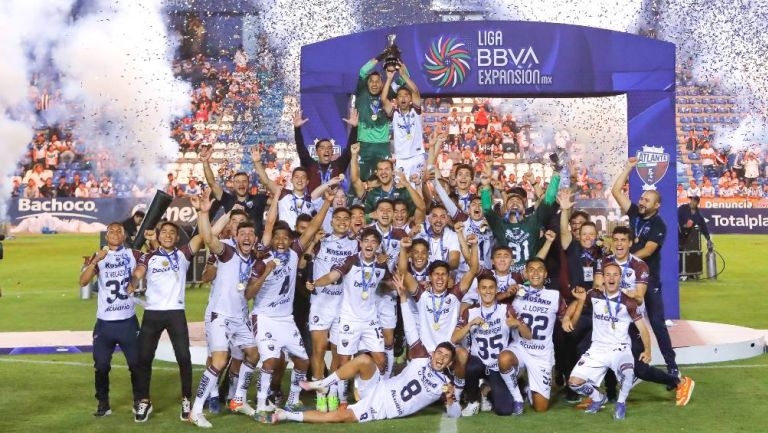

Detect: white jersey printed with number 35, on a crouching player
[458, 302, 517, 371]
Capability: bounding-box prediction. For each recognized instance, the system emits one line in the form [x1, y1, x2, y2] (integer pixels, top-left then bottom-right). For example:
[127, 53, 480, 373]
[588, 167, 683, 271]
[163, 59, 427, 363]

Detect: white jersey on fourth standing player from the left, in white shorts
[251, 240, 304, 317]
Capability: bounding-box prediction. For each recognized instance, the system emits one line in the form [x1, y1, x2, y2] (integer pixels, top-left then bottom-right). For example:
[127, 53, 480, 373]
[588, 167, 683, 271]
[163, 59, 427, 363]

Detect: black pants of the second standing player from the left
[134, 310, 192, 400]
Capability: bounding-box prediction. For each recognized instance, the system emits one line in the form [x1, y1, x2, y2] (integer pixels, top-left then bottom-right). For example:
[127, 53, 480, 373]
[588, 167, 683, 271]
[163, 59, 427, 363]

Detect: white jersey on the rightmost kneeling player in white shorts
[584, 289, 643, 350]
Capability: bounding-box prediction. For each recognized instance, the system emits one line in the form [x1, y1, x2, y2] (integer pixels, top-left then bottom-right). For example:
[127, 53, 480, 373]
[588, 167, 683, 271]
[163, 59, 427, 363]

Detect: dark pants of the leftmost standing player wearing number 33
[93, 316, 139, 403]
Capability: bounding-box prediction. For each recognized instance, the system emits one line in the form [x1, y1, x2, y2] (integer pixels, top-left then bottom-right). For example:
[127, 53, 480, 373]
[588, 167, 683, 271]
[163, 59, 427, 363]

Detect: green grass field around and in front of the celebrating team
[0, 235, 768, 433]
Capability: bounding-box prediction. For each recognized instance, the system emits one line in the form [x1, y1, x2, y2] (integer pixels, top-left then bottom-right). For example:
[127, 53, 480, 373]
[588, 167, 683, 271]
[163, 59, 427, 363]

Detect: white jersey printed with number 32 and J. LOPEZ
[512, 286, 566, 362]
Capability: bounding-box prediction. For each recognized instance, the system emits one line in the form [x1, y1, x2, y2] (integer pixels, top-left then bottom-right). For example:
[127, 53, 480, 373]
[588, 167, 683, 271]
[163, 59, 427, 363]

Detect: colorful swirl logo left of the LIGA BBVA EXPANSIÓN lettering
[424, 36, 471, 87]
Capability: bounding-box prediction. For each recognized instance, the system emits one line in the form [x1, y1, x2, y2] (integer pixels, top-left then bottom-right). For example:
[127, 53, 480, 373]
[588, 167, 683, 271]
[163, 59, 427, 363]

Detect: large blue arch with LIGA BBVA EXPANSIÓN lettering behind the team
[301, 21, 680, 318]
